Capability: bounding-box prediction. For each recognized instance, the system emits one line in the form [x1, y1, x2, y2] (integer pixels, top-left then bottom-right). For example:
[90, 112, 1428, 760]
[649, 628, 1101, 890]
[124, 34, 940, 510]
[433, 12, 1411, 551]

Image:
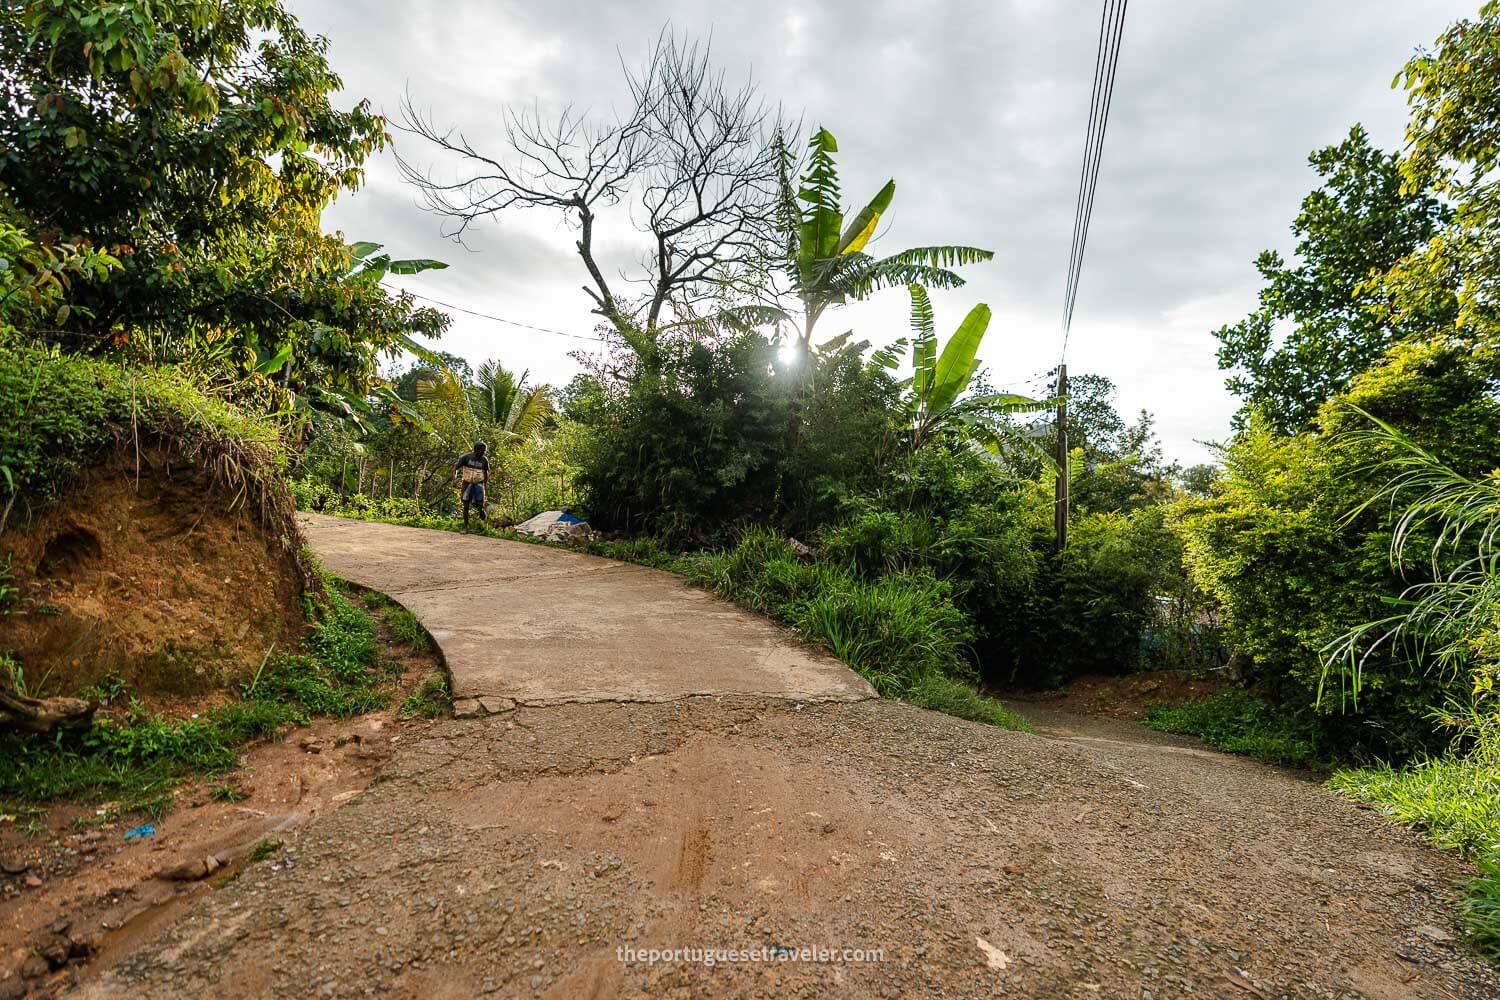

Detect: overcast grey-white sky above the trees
[290, 0, 1478, 462]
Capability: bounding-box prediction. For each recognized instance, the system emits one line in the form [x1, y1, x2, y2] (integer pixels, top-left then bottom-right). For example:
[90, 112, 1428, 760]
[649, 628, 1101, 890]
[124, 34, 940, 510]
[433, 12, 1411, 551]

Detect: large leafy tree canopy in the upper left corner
[0, 0, 446, 402]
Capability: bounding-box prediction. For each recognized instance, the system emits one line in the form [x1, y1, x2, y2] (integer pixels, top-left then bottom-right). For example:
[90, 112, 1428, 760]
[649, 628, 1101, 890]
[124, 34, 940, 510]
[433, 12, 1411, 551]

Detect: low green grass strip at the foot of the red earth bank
[0, 582, 390, 816]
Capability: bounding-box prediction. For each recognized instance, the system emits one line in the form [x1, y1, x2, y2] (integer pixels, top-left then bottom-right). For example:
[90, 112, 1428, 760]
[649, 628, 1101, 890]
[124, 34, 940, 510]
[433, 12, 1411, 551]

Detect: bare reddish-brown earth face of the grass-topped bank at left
[0, 451, 303, 694]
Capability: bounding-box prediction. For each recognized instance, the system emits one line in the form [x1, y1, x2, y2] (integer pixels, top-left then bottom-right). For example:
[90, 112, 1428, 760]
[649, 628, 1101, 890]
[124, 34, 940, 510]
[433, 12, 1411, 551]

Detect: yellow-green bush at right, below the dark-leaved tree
[1172, 343, 1500, 757]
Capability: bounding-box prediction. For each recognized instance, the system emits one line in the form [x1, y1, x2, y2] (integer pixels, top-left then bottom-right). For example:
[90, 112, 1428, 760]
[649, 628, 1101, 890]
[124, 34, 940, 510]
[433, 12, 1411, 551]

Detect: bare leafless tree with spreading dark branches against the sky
[401, 30, 785, 340]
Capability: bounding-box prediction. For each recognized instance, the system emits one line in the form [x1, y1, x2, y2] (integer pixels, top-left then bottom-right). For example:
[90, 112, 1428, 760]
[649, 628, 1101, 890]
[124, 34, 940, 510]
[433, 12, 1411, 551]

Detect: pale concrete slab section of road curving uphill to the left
[302, 514, 875, 715]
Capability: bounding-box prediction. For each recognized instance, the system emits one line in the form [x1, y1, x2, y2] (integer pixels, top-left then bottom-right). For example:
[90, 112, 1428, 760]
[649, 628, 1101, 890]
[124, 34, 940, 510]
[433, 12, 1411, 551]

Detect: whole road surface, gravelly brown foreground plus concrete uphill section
[81, 523, 1500, 999]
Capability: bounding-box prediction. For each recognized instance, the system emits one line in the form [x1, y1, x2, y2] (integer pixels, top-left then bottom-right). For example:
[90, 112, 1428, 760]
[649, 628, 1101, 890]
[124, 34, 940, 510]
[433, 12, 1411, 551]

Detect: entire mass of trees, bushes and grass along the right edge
[1176, 7, 1500, 960]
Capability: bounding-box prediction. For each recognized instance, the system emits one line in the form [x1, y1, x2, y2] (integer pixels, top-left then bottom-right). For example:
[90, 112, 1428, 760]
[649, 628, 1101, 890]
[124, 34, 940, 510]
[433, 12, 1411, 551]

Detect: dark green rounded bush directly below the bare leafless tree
[564, 334, 897, 543]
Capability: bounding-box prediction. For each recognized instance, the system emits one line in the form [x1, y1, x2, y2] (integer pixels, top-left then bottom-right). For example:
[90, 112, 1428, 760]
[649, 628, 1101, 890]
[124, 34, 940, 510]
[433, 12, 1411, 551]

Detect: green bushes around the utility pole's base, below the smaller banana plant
[819, 447, 1200, 687]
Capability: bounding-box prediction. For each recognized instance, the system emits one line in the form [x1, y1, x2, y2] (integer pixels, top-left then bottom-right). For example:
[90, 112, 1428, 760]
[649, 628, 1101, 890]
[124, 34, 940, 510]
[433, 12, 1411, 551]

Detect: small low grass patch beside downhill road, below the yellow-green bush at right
[1142, 688, 1326, 769]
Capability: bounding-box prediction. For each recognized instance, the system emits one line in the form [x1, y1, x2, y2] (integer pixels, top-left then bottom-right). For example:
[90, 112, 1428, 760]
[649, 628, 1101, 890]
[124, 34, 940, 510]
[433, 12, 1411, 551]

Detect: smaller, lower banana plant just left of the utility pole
[872, 285, 1047, 454]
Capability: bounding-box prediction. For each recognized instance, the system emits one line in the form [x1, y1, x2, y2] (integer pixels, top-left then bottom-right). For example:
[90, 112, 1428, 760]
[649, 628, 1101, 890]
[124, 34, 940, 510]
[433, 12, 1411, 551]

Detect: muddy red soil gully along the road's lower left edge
[0, 614, 443, 997]
